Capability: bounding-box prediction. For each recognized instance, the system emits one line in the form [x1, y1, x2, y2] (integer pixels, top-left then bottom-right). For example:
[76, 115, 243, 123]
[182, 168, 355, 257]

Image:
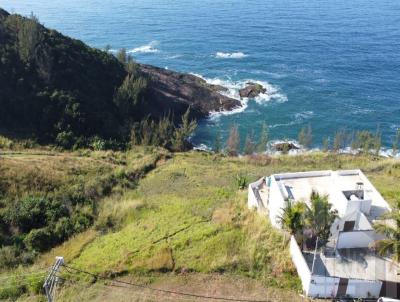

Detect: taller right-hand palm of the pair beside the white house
[305, 191, 338, 243]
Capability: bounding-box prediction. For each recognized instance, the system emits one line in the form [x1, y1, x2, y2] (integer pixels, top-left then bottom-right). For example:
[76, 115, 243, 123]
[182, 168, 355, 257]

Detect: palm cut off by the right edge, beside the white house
[374, 199, 400, 262]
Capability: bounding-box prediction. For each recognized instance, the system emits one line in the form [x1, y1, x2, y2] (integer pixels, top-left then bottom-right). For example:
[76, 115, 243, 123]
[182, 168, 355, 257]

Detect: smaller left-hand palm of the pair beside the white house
[278, 199, 306, 235]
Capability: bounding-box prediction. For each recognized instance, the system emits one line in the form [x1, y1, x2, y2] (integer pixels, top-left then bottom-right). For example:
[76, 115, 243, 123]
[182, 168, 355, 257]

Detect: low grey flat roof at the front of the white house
[303, 248, 400, 283]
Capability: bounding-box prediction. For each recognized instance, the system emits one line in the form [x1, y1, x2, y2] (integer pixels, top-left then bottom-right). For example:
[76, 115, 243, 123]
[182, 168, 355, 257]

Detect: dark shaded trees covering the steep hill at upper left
[0, 9, 193, 150]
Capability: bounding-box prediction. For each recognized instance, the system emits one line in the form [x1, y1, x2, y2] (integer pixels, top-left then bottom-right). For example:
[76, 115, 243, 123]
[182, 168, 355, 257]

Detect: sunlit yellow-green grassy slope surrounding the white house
[0, 152, 400, 301]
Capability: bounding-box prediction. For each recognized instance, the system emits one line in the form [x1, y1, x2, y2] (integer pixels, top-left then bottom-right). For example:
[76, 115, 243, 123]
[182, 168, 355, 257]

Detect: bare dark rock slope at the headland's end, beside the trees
[139, 64, 241, 118]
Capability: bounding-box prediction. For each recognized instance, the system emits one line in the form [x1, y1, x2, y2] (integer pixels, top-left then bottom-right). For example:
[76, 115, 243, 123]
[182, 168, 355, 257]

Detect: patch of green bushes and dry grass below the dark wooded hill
[0, 148, 167, 269]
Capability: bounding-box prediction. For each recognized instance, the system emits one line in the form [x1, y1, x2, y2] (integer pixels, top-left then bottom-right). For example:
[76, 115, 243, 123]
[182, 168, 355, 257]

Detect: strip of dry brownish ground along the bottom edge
[59, 273, 316, 302]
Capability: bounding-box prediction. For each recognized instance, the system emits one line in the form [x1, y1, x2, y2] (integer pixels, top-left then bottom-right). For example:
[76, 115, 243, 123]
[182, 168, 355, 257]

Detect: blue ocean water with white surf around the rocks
[0, 0, 400, 147]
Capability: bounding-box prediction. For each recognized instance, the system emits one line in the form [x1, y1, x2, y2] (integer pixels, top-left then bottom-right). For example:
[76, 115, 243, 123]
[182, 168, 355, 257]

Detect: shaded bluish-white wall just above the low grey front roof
[336, 230, 383, 249]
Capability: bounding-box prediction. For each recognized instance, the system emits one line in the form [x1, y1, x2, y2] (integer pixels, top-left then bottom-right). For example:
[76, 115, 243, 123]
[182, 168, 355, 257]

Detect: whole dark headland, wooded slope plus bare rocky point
[0, 9, 240, 142]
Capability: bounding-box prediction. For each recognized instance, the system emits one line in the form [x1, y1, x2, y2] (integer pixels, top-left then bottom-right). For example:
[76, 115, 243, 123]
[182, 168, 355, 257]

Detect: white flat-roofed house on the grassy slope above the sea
[248, 170, 400, 298]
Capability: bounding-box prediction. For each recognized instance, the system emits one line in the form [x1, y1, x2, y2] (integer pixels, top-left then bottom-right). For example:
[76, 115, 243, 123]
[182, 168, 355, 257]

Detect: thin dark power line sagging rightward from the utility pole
[63, 264, 273, 302]
